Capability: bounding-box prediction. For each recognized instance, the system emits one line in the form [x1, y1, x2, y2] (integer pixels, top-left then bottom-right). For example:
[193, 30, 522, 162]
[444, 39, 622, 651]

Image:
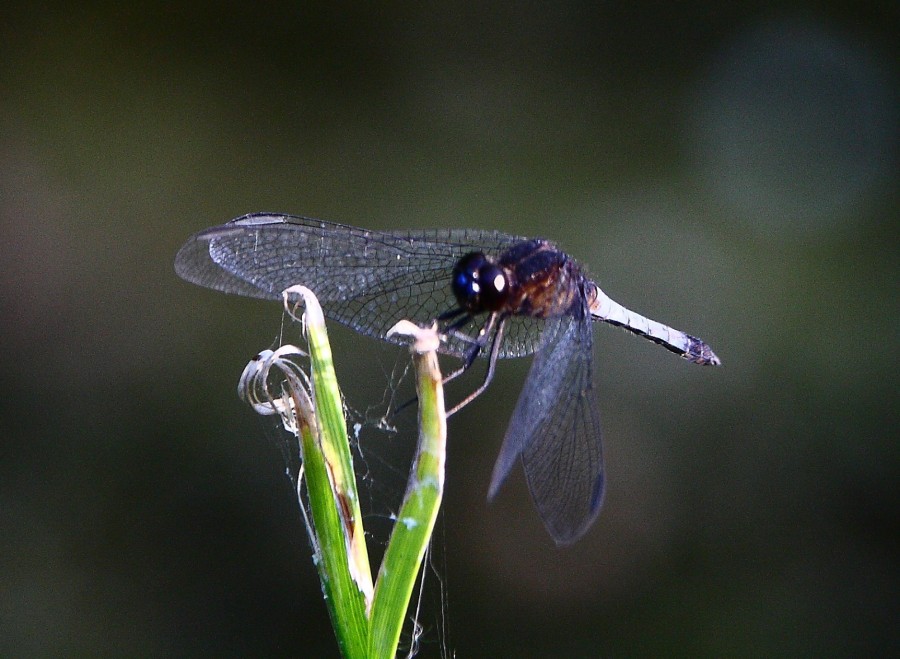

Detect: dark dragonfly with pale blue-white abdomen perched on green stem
[175, 213, 720, 545]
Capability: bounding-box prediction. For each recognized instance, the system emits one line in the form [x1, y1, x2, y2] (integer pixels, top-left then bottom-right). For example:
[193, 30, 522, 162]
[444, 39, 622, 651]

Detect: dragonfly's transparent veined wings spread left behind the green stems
[175, 213, 543, 357]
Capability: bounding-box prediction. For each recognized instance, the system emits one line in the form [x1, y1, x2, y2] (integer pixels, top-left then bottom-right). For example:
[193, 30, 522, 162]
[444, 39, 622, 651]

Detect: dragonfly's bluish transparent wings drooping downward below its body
[489, 302, 604, 544]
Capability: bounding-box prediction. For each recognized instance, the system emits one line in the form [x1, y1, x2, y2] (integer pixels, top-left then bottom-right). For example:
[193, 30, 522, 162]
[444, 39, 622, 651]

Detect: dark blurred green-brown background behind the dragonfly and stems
[0, 2, 900, 657]
